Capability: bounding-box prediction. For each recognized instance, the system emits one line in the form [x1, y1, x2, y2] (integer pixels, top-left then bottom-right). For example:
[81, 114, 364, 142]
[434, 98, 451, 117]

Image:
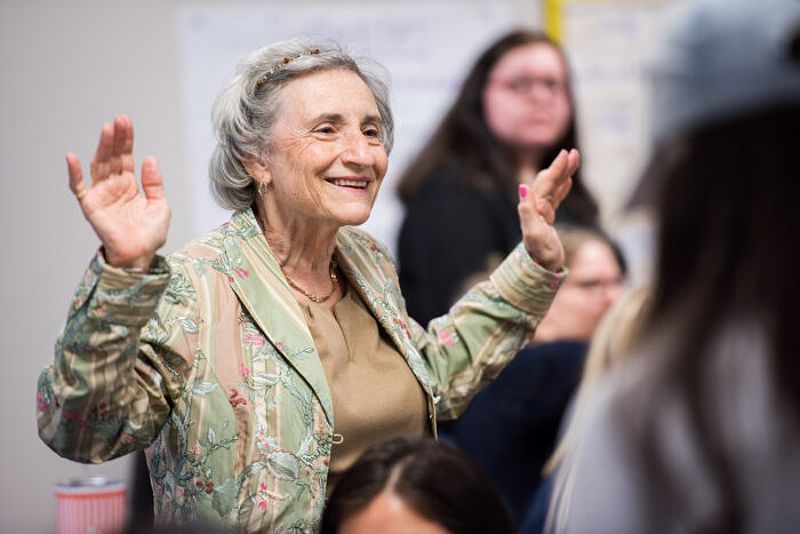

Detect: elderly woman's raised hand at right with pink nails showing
[517, 148, 580, 272]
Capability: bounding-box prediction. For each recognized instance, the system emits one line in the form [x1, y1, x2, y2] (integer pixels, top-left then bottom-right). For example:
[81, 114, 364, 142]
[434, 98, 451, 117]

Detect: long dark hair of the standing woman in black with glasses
[397, 30, 598, 225]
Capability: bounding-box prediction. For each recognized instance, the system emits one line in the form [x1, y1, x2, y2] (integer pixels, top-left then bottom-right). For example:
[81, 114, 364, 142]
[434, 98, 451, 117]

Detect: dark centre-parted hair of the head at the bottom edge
[322, 438, 515, 534]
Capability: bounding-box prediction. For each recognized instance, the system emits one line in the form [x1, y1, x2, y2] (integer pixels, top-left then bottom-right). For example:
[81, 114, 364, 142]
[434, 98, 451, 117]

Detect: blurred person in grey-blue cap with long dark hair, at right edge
[551, 0, 800, 533]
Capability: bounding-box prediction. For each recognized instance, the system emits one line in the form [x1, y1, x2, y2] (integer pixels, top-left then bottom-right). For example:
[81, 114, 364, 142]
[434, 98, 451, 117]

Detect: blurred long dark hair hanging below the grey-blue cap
[631, 105, 800, 532]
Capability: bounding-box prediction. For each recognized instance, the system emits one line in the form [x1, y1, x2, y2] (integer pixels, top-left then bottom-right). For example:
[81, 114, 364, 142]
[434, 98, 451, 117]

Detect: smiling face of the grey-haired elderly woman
[257, 69, 388, 227]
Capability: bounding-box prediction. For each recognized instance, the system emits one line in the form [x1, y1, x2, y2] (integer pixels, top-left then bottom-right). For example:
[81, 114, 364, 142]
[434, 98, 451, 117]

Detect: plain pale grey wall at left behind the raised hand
[0, 0, 538, 532]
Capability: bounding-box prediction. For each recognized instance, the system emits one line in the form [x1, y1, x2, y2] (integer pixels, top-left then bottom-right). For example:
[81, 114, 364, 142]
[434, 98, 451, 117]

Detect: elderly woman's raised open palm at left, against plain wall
[67, 115, 170, 270]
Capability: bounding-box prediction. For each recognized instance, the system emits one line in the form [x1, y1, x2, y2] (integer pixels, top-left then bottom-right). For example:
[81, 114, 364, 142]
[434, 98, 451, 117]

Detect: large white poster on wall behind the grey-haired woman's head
[178, 1, 515, 255]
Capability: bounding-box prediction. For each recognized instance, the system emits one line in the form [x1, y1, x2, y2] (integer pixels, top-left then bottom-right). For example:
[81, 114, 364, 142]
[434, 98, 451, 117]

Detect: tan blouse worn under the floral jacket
[301, 287, 427, 495]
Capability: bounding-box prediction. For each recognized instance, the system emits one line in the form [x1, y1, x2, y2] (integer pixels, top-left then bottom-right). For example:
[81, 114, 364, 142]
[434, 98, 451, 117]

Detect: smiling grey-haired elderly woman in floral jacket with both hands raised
[38, 40, 579, 531]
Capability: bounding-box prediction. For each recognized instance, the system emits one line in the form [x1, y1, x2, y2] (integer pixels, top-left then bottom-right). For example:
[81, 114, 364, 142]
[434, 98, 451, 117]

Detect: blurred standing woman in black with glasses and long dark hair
[397, 30, 598, 330]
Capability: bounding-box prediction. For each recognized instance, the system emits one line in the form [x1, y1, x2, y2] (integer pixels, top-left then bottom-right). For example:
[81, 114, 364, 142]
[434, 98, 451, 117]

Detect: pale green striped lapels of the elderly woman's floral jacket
[223, 209, 433, 426]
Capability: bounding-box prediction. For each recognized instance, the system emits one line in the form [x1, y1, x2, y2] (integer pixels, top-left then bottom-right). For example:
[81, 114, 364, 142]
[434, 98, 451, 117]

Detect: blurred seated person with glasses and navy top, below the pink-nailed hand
[440, 225, 624, 522]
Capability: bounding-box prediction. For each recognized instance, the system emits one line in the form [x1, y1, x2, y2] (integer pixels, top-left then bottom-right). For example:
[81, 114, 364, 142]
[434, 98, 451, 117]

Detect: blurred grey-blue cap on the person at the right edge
[650, 0, 800, 143]
